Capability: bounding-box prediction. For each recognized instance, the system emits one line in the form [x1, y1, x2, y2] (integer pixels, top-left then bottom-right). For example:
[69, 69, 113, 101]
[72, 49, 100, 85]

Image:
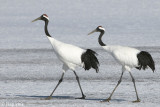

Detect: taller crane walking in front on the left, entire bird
[32, 14, 99, 99]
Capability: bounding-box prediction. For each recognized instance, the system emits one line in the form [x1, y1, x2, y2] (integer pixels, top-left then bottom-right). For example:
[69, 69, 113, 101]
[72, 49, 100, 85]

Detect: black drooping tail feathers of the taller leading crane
[81, 49, 99, 72]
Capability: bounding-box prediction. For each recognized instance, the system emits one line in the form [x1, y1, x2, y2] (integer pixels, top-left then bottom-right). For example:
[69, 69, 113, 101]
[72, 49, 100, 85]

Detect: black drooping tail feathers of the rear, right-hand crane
[136, 51, 155, 72]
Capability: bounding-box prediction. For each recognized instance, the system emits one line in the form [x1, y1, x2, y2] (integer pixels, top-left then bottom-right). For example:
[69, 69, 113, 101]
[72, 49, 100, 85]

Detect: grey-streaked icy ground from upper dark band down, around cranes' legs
[0, 47, 160, 107]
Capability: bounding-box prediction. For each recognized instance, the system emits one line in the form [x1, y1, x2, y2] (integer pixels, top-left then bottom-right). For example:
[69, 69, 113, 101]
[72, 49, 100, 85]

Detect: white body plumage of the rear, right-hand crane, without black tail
[102, 45, 140, 71]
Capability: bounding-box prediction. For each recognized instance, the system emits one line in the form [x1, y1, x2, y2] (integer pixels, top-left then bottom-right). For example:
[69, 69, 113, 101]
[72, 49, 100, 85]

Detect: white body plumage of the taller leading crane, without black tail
[47, 36, 86, 70]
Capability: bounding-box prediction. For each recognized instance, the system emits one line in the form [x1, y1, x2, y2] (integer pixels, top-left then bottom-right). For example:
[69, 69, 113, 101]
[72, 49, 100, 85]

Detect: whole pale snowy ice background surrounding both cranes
[0, 0, 160, 107]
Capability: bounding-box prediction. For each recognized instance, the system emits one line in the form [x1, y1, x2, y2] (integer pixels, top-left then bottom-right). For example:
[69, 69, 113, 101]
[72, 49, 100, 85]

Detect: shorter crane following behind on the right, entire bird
[88, 26, 155, 102]
